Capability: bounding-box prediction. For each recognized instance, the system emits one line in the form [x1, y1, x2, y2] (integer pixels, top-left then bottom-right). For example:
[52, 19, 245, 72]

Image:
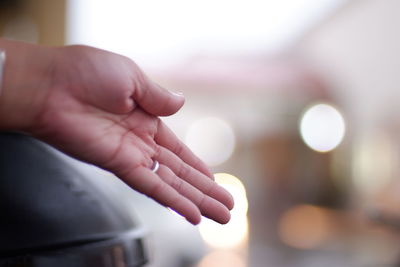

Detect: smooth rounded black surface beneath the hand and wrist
[0, 133, 144, 266]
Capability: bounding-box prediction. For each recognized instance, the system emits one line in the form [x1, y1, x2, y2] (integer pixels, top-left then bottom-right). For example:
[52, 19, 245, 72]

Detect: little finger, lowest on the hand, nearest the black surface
[120, 166, 201, 224]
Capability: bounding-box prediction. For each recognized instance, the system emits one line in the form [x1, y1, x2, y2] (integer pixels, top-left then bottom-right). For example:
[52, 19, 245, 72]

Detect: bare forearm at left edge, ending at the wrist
[0, 39, 54, 131]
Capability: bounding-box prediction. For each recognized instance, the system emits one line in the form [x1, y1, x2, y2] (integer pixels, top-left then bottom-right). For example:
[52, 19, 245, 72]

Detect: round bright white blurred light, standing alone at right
[300, 104, 345, 152]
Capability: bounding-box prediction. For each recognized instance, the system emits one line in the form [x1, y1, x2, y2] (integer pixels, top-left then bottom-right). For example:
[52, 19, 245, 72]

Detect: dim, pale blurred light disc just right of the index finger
[185, 117, 235, 166]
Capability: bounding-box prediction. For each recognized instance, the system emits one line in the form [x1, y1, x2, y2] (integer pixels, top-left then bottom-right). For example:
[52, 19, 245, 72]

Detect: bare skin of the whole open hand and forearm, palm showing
[0, 39, 233, 224]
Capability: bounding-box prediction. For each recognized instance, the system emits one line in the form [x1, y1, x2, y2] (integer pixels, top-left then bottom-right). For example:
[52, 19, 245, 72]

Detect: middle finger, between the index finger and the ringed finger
[156, 147, 234, 210]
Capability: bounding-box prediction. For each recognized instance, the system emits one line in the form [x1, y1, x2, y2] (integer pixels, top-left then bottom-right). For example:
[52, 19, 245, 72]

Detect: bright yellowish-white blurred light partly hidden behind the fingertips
[199, 173, 249, 249]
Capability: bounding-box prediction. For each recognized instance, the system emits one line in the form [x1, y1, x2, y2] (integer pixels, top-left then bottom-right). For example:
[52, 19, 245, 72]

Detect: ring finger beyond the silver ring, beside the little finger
[157, 164, 230, 224]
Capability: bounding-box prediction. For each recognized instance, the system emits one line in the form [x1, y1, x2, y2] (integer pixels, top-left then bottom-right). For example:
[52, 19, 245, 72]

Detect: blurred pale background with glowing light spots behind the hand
[0, 0, 400, 267]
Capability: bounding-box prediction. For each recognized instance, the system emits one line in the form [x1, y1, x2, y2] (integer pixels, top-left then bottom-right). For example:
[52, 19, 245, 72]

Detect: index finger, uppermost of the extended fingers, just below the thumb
[154, 120, 214, 180]
